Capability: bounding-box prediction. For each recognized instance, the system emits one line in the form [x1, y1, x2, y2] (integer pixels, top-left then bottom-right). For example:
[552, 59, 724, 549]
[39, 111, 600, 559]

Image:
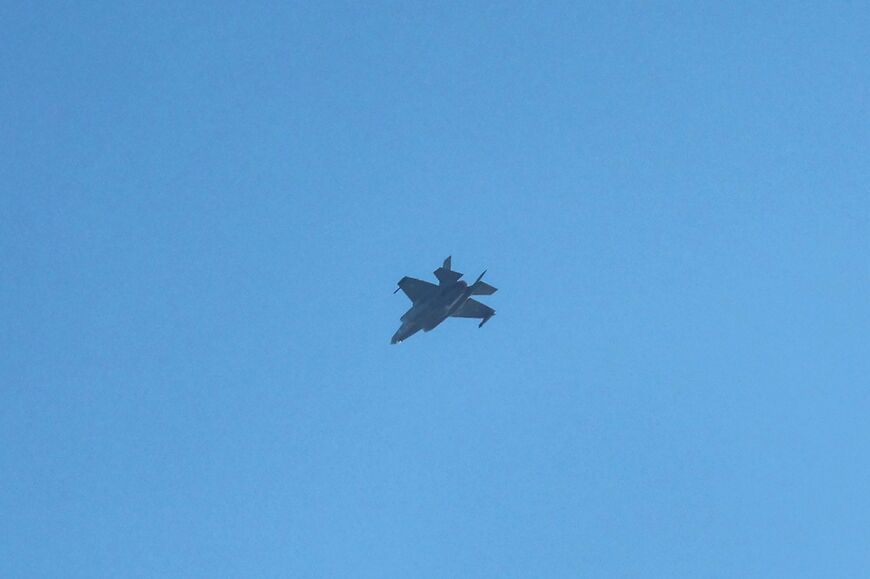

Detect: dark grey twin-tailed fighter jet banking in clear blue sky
[390, 257, 496, 344]
